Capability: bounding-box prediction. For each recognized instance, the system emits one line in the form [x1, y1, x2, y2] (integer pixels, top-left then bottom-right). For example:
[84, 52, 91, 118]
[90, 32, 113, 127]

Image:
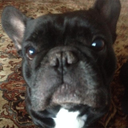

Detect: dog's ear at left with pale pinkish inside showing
[1, 6, 27, 51]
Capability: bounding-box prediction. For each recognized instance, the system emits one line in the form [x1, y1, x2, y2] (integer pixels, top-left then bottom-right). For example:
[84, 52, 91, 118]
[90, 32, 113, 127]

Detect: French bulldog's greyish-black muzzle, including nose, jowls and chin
[27, 47, 109, 110]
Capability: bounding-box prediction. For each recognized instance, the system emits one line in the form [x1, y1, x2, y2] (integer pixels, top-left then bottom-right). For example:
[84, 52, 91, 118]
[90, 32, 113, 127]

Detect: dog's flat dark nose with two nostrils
[50, 51, 78, 68]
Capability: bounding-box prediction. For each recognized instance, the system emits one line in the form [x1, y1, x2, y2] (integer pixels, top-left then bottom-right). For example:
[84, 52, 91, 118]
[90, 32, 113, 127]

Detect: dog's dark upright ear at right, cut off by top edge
[94, 0, 121, 41]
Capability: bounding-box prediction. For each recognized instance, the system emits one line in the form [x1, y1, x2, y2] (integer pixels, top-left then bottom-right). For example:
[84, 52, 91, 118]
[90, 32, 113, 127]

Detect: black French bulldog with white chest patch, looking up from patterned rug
[2, 0, 120, 128]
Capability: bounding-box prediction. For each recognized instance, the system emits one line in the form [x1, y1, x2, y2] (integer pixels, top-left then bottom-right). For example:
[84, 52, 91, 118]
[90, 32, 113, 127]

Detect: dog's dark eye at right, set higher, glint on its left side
[91, 39, 105, 51]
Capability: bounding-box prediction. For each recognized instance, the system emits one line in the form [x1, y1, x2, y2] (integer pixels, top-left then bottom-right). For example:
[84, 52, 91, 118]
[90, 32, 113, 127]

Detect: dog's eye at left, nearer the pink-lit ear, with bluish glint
[26, 46, 36, 60]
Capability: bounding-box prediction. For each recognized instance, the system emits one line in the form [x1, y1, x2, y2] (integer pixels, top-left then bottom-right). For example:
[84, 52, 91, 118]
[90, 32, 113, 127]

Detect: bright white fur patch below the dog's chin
[53, 108, 87, 128]
